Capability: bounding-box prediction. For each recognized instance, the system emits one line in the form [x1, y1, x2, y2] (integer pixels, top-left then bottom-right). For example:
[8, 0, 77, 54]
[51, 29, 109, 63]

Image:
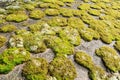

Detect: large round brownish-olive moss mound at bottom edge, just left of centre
[49, 57, 77, 80]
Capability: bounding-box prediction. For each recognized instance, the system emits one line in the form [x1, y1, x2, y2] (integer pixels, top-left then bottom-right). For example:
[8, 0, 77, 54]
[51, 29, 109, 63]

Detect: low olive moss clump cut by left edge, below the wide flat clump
[0, 24, 17, 33]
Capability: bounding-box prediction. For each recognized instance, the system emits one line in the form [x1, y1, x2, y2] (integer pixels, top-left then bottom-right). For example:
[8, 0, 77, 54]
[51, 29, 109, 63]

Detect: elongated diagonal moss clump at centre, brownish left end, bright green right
[46, 36, 74, 55]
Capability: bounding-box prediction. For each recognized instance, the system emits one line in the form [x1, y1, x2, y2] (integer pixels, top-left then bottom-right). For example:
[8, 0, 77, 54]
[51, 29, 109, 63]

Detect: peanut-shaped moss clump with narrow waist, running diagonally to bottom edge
[74, 51, 106, 80]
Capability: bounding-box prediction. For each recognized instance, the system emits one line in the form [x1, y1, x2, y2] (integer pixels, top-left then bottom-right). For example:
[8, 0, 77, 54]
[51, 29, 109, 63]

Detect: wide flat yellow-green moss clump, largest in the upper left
[6, 12, 28, 22]
